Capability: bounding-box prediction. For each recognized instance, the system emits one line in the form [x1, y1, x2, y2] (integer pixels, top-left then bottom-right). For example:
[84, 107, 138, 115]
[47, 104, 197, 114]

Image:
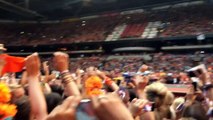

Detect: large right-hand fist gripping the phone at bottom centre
[92, 94, 133, 120]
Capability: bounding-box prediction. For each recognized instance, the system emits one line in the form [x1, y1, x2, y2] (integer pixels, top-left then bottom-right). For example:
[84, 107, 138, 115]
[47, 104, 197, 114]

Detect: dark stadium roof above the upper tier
[0, 0, 206, 20]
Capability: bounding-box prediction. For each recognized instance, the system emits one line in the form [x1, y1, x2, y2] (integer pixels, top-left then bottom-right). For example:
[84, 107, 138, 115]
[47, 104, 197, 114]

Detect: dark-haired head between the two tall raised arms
[45, 93, 63, 113]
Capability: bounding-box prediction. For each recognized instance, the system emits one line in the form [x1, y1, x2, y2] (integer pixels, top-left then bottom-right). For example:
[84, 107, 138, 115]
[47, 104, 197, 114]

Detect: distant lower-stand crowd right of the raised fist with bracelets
[67, 53, 213, 73]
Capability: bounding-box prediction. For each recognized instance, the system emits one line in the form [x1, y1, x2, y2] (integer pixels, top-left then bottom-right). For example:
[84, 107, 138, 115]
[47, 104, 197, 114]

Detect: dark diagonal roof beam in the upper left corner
[0, 0, 46, 18]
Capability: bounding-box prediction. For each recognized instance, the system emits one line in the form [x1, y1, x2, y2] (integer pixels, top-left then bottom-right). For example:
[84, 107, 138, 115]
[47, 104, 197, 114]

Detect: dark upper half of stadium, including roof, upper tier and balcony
[0, 0, 213, 54]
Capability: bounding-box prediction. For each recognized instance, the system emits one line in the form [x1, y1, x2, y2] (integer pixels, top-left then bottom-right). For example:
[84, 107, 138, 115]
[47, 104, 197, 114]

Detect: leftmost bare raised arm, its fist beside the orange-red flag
[26, 53, 47, 120]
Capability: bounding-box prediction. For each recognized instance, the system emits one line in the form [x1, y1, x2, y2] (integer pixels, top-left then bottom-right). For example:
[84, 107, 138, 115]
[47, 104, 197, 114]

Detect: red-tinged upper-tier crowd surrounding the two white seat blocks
[0, 5, 213, 45]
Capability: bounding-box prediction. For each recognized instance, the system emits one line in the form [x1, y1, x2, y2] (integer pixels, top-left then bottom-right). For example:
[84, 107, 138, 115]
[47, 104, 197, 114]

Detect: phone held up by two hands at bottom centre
[76, 99, 98, 120]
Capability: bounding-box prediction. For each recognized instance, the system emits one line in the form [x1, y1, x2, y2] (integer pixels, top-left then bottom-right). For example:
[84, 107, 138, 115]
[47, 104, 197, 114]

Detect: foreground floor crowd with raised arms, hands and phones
[0, 52, 213, 120]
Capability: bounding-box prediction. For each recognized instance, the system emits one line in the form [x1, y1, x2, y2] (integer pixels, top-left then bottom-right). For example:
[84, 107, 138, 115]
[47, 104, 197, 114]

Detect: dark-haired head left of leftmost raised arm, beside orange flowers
[14, 96, 31, 120]
